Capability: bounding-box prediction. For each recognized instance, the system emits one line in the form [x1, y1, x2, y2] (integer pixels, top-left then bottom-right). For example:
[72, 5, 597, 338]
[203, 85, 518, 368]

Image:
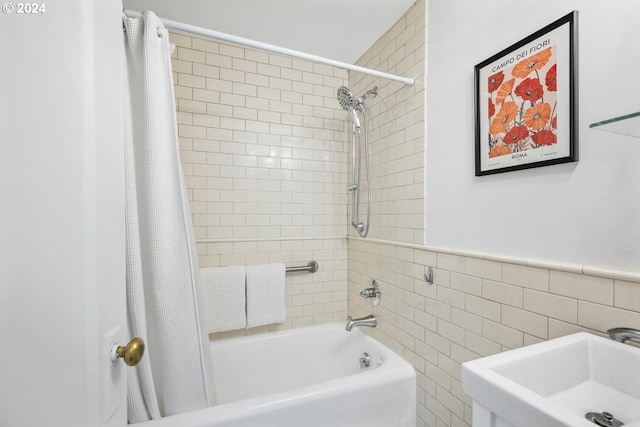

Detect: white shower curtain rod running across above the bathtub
[124, 10, 415, 85]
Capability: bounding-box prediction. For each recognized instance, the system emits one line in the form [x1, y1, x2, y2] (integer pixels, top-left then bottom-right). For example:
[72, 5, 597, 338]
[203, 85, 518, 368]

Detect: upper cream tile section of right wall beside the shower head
[349, 0, 426, 244]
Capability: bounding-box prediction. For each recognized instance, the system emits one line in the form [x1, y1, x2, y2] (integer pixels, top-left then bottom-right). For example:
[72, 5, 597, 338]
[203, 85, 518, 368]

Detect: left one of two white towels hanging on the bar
[200, 265, 247, 333]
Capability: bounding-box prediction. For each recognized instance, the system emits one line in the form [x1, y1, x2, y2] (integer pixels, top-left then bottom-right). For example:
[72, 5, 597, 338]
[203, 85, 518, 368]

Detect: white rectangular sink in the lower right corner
[462, 332, 640, 427]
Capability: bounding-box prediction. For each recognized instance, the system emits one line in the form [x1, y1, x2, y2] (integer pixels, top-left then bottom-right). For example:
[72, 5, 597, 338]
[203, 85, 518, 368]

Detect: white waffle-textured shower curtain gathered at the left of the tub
[123, 12, 215, 423]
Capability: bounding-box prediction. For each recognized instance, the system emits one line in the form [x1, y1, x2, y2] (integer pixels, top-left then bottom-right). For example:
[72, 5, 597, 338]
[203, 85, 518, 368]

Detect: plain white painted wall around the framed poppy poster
[426, 0, 640, 271]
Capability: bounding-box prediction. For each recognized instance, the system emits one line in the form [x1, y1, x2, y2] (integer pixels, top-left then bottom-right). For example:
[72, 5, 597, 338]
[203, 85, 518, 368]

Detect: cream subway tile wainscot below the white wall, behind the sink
[349, 239, 640, 427]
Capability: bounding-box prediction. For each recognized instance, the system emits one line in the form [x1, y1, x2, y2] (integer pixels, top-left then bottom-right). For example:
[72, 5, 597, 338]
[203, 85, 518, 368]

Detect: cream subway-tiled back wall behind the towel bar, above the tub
[170, 33, 348, 338]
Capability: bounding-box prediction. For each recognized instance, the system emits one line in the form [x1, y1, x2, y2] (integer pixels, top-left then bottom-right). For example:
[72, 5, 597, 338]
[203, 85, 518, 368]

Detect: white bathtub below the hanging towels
[138, 323, 416, 427]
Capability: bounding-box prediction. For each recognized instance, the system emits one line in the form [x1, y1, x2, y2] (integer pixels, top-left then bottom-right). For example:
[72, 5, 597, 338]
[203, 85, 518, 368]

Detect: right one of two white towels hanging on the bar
[247, 263, 287, 328]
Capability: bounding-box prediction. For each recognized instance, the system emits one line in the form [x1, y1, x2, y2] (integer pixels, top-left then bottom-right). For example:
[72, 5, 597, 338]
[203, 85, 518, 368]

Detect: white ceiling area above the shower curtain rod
[123, 0, 415, 64]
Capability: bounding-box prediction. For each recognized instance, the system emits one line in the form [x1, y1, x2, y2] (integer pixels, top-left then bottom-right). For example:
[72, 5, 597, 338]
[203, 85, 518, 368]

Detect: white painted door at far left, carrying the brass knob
[0, 0, 126, 427]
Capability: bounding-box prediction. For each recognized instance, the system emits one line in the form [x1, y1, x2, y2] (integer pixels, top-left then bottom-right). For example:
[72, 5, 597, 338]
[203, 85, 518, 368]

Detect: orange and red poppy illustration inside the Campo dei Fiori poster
[486, 45, 558, 158]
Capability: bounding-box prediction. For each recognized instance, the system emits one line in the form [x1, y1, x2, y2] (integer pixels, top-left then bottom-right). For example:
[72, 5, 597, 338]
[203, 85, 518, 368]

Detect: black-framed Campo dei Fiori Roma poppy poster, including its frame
[475, 11, 578, 176]
